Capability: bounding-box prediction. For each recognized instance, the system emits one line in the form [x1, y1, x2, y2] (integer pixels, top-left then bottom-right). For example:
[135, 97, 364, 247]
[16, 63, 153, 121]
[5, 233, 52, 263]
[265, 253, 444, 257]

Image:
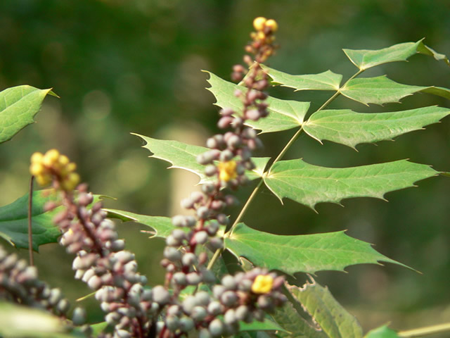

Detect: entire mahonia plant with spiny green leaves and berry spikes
[0, 17, 450, 338]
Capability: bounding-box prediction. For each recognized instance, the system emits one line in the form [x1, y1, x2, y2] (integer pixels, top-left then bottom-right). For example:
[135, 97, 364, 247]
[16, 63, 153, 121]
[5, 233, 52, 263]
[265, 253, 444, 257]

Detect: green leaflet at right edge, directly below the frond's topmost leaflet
[340, 76, 450, 105]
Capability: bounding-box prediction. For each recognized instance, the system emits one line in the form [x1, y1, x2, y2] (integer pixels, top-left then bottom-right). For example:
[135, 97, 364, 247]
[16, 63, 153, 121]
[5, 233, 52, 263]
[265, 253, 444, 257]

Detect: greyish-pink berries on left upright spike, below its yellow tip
[54, 185, 159, 338]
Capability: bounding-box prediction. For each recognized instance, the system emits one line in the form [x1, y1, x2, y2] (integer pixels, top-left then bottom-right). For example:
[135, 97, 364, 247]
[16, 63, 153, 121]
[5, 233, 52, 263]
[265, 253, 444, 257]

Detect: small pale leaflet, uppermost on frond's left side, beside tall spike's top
[262, 65, 342, 91]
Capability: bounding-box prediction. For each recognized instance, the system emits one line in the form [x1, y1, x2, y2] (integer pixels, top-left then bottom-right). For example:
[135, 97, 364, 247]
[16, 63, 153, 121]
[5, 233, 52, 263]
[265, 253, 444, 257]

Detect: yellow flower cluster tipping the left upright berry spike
[30, 149, 80, 191]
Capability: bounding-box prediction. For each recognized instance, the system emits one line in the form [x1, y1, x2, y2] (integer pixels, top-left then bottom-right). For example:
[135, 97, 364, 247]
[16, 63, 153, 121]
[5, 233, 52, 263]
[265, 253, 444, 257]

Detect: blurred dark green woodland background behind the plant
[0, 0, 450, 330]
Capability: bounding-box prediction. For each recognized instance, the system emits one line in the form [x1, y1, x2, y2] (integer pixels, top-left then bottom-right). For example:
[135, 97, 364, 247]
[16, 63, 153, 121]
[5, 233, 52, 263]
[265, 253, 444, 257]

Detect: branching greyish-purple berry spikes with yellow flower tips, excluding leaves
[0, 18, 286, 338]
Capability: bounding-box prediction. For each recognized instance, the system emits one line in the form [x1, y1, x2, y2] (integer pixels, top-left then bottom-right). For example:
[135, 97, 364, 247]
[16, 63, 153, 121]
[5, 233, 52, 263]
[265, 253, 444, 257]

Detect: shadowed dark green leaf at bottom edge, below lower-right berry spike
[273, 302, 328, 338]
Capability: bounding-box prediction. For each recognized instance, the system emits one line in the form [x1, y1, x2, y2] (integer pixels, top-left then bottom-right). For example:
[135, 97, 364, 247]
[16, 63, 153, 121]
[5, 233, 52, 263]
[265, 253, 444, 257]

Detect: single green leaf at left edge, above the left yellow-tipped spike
[0, 86, 55, 143]
